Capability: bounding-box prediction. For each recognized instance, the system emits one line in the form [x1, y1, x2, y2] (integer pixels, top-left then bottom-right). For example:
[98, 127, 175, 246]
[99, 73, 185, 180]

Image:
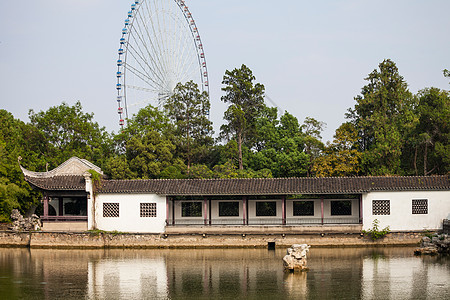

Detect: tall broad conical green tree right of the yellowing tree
[347, 59, 417, 175]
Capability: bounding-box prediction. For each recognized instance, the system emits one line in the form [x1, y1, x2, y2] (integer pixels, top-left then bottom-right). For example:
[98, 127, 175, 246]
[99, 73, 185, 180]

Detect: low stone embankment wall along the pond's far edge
[0, 231, 423, 249]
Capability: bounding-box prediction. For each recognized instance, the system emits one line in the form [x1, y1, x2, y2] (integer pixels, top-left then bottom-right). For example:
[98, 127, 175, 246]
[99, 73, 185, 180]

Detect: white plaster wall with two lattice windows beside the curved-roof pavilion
[95, 194, 166, 233]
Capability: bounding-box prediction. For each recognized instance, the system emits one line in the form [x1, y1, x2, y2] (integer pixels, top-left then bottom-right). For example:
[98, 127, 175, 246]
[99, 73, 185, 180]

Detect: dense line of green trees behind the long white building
[0, 60, 450, 221]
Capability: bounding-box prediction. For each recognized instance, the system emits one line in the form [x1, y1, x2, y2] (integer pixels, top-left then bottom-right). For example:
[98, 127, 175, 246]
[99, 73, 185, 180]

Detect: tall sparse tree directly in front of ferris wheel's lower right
[164, 81, 214, 174]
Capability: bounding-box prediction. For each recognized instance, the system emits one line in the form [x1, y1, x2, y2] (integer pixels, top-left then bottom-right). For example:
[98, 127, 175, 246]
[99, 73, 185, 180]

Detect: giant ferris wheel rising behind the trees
[116, 0, 209, 128]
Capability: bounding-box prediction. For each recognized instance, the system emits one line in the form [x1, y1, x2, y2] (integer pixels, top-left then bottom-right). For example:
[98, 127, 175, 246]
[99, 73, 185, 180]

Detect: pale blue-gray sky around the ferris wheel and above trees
[0, 0, 450, 141]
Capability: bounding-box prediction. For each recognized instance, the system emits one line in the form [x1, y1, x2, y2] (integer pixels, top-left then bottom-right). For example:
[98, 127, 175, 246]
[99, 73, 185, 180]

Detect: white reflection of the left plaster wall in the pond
[87, 257, 168, 299]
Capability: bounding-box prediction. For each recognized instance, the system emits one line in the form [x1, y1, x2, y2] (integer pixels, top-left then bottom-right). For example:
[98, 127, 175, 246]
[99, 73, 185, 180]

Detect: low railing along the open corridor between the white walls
[167, 218, 360, 226]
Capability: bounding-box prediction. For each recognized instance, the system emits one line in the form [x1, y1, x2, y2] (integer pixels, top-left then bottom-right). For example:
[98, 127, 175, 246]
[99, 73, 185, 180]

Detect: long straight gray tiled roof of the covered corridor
[99, 176, 450, 196]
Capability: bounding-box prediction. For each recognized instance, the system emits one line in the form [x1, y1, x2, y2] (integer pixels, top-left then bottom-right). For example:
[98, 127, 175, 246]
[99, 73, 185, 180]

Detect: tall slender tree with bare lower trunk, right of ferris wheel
[220, 65, 265, 170]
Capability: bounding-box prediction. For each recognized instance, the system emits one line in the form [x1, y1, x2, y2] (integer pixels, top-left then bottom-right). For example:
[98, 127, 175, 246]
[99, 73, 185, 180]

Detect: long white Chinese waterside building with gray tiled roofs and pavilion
[22, 158, 450, 233]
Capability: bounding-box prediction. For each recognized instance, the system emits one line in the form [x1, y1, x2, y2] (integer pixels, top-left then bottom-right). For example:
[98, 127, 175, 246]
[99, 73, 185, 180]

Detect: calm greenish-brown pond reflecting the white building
[0, 247, 450, 299]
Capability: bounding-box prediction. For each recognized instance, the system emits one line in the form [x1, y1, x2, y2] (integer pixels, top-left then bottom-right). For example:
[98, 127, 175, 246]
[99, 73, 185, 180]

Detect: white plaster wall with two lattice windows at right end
[363, 191, 450, 231]
